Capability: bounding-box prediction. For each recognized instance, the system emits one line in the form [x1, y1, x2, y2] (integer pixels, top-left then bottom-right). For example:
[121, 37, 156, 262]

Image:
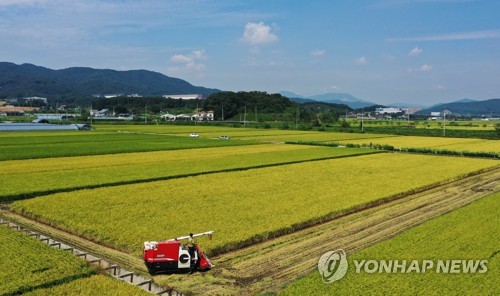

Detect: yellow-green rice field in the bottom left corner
[0, 225, 148, 295]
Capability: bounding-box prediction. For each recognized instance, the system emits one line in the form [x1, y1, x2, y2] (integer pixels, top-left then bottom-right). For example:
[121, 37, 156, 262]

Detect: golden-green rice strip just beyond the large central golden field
[0, 144, 377, 201]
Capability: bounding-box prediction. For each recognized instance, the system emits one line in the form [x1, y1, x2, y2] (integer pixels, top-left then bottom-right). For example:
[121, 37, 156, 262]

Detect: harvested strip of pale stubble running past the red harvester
[0, 166, 500, 295]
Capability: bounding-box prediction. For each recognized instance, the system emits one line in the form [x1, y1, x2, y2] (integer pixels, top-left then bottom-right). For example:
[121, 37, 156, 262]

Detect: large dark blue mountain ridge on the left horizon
[0, 62, 219, 102]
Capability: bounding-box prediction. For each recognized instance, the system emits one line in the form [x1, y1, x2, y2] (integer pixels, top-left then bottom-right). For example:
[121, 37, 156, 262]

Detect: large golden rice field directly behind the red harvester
[11, 153, 498, 255]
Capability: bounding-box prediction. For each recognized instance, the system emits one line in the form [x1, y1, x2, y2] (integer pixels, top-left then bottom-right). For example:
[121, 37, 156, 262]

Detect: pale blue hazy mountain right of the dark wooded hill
[280, 91, 376, 109]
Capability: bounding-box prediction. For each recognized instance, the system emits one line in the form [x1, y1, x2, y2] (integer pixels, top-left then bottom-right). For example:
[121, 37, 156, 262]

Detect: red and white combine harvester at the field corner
[143, 231, 214, 274]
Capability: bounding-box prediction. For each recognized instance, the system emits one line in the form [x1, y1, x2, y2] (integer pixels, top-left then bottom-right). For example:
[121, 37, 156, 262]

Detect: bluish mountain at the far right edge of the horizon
[417, 99, 500, 117]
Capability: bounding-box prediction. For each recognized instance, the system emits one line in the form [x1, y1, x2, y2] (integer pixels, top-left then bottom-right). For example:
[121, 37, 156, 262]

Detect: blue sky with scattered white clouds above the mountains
[0, 0, 500, 105]
